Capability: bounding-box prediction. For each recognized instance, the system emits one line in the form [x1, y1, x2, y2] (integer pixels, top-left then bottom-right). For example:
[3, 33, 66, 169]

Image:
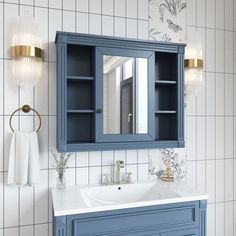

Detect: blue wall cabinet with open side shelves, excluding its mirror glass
[56, 32, 185, 152]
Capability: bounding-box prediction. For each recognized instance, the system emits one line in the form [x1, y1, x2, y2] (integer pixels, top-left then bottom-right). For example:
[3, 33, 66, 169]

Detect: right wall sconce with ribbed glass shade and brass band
[185, 48, 203, 90]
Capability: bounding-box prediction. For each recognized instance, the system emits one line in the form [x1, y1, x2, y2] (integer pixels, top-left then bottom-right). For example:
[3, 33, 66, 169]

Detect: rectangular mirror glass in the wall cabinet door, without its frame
[103, 55, 148, 134]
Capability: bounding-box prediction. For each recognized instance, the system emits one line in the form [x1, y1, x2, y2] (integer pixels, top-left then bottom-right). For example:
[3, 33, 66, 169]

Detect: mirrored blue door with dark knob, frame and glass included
[96, 47, 155, 142]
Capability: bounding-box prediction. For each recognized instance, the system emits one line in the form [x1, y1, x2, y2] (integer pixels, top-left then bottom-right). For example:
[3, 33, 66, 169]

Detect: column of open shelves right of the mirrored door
[155, 52, 178, 141]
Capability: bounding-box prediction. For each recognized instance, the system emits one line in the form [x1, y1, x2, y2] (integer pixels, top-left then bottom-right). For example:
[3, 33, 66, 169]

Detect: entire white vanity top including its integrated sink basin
[51, 181, 208, 216]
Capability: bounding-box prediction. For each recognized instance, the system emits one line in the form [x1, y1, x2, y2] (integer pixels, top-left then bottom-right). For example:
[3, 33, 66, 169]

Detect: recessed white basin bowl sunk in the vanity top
[80, 183, 180, 207]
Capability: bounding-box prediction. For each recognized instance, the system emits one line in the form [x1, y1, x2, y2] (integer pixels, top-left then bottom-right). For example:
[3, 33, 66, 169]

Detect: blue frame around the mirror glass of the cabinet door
[95, 47, 155, 143]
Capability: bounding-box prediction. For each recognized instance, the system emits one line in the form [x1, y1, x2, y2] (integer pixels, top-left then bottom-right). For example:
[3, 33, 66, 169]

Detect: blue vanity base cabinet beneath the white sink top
[53, 200, 207, 236]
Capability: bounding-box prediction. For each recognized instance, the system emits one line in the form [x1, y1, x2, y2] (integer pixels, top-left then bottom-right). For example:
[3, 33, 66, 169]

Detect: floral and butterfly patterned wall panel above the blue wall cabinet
[149, 0, 187, 42]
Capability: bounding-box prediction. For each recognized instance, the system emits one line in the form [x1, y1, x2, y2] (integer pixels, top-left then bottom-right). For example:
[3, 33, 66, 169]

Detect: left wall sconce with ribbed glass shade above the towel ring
[11, 16, 43, 86]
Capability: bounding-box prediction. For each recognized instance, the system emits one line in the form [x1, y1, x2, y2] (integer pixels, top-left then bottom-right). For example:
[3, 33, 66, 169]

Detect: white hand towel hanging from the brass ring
[8, 132, 40, 185]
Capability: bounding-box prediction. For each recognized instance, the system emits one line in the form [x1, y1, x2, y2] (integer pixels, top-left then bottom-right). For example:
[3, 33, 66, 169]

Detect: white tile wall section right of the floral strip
[186, 0, 236, 236]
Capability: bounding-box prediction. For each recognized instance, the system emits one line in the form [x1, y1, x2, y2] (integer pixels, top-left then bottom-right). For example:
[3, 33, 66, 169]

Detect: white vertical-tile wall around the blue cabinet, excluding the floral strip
[0, 0, 236, 236]
